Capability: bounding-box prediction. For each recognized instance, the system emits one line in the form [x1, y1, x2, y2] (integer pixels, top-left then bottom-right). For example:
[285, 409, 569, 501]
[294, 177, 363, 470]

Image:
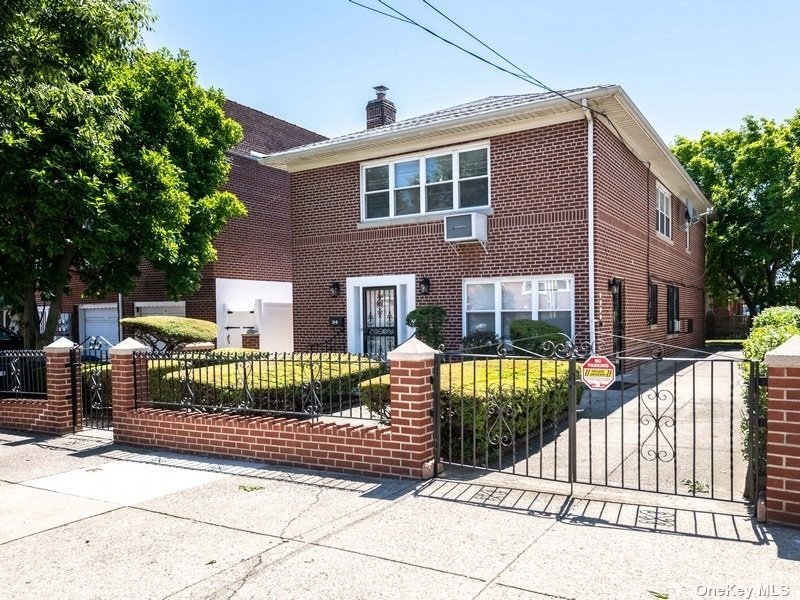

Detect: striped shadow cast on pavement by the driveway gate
[415, 479, 768, 548]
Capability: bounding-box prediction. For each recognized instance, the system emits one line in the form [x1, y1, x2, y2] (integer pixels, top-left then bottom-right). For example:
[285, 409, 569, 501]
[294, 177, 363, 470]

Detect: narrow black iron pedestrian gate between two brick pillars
[70, 336, 112, 429]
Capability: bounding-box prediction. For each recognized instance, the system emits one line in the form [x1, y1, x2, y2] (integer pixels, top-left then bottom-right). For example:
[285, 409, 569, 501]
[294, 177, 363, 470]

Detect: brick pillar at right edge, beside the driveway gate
[764, 336, 800, 526]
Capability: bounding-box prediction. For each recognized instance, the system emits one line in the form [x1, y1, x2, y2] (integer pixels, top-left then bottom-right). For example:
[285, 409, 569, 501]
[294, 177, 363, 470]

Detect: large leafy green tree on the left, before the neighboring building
[0, 0, 245, 347]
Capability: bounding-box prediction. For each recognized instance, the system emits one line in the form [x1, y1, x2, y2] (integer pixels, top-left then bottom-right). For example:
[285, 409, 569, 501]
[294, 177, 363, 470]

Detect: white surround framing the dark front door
[346, 275, 417, 354]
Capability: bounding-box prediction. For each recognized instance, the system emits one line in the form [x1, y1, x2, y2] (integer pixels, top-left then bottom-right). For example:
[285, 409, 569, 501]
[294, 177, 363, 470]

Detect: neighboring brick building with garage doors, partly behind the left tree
[56, 100, 325, 350]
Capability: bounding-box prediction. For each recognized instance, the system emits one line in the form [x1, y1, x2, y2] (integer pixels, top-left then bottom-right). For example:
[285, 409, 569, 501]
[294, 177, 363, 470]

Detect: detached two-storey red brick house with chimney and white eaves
[261, 85, 710, 353]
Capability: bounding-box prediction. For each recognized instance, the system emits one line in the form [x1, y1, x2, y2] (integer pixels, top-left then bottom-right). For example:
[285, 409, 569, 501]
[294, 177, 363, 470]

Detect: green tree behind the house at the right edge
[673, 111, 800, 314]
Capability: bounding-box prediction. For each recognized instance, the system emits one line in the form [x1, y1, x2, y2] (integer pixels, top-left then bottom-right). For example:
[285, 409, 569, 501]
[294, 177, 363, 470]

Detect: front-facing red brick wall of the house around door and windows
[291, 121, 588, 349]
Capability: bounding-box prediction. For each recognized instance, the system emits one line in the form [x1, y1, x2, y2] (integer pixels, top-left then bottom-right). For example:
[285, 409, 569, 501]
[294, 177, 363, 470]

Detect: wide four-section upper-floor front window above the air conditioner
[361, 146, 489, 220]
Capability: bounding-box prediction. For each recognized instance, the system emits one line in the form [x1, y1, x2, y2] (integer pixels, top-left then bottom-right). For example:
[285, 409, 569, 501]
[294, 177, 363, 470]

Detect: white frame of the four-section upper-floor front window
[360, 141, 492, 223]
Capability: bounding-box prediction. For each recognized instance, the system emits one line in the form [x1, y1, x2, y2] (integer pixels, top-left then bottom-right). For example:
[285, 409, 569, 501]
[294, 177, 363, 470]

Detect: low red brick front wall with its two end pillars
[112, 352, 434, 478]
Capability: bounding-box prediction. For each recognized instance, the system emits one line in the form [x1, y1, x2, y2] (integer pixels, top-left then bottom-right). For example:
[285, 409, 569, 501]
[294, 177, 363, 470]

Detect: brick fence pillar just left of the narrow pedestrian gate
[39, 337, 83, 435]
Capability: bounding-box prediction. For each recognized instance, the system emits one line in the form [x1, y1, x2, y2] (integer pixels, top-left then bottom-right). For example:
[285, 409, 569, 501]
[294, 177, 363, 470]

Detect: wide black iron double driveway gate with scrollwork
[435, 342, 763, 501]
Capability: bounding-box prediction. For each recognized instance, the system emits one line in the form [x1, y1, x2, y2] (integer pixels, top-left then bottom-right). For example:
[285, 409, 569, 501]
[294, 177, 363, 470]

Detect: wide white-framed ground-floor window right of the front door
[462, 275, 575, 339]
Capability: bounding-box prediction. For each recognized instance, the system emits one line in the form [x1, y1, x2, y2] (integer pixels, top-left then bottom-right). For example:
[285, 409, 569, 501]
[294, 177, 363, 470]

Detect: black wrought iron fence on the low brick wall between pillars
[134, 351, 389, 422]
